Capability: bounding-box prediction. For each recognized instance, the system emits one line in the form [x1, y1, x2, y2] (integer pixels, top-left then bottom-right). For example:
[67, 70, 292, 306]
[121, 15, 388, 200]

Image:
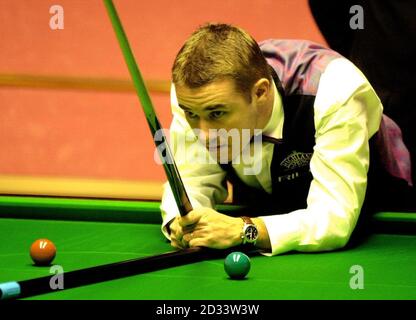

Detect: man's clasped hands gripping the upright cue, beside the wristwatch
[179, 208, 244, 249]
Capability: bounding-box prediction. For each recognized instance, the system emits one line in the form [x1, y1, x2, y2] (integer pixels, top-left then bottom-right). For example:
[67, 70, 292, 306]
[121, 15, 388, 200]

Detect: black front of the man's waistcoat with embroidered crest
[220, 68, 315, 215]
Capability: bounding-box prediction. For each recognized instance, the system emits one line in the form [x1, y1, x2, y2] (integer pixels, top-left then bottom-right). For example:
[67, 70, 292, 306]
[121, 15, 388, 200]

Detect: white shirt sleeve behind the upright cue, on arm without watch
[160, 85, 228, 239]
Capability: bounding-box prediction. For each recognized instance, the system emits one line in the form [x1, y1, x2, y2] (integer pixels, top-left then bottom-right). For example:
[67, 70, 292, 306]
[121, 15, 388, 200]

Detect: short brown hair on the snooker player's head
[172, 23, 271, 100]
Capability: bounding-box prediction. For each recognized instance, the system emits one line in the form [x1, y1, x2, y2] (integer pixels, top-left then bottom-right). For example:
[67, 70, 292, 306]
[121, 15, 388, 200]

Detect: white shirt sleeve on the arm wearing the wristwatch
[260, 59, 383, 255]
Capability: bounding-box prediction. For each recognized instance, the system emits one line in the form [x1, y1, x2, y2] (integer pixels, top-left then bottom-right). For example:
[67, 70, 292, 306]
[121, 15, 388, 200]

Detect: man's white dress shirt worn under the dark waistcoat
[161, 58, 383, 255]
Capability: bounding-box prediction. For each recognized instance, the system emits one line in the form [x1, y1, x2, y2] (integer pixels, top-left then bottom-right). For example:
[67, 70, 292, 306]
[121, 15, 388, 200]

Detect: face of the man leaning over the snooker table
[176, 79, 258, 161]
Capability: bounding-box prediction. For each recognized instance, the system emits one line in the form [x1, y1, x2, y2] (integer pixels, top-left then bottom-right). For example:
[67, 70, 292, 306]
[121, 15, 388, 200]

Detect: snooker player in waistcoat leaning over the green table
[161, 24, 412, 255]
